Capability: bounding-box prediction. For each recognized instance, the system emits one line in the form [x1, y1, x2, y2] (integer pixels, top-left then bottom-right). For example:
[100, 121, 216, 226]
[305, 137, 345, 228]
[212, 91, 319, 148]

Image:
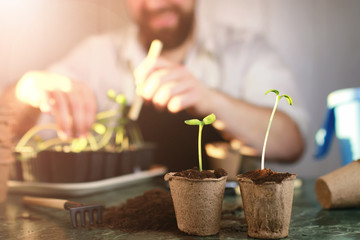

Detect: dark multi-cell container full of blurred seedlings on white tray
[12, 90, 153, 183]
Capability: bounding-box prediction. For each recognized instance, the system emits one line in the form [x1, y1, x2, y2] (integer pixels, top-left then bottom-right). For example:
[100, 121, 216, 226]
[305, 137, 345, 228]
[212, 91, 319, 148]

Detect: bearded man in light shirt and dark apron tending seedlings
[2, 0, 306, 170]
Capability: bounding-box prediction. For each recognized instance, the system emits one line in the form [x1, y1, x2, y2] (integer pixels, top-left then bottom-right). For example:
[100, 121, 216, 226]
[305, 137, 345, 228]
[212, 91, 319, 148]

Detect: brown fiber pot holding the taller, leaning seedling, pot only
[237, 174, 296, 239]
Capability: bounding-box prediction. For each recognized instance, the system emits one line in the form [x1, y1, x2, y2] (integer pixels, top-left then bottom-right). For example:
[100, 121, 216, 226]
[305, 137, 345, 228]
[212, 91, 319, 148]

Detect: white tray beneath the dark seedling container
[8, 167, 167, 196]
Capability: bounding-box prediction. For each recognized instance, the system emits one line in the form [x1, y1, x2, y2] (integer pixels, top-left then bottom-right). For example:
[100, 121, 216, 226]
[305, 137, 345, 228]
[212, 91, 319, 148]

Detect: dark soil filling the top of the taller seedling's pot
[242, 168, 292, 184]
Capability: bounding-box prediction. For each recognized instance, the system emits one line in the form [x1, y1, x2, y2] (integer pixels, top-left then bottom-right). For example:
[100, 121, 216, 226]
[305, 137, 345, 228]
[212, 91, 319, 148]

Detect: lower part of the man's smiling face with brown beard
[127, 0, 195, 50]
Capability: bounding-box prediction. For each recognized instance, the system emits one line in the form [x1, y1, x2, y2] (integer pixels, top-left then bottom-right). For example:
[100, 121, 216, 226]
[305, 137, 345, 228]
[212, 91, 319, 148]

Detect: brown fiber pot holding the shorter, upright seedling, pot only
[164, 172, 227, 236]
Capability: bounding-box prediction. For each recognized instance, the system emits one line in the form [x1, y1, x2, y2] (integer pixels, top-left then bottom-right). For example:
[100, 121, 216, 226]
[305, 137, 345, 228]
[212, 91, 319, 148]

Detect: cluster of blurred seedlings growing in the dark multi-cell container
[15, 89, 143, 152]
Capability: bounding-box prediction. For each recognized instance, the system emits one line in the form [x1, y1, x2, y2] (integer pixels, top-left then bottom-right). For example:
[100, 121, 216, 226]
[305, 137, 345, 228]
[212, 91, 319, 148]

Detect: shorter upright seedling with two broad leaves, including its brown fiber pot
[164, 114, 227, 236]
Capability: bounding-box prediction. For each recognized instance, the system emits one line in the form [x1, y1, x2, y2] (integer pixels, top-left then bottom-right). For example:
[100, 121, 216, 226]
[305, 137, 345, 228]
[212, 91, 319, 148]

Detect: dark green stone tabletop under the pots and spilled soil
[0, 177, 360, 240]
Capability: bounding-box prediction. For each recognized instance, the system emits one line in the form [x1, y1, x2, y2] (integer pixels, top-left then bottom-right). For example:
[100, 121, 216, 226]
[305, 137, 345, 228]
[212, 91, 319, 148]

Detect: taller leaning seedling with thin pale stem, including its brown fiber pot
[237, 89, 296, 239]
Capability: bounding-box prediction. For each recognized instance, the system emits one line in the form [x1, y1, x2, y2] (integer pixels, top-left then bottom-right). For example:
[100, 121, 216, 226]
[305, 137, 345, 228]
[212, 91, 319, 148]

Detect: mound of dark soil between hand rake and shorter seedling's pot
[100, 188, 177, 232]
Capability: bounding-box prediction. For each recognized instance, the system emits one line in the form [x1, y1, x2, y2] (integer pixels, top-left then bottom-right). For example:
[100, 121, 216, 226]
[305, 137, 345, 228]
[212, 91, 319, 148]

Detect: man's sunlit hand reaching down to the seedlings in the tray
[15, 71, 96, 139]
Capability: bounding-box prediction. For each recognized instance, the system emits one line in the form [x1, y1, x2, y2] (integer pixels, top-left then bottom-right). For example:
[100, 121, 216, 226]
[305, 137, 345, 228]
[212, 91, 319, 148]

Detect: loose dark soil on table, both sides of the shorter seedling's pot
[98, 188, 243, 235]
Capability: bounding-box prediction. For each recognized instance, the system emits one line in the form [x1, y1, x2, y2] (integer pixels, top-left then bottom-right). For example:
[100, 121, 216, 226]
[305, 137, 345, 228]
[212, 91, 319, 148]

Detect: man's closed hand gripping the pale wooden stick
[135, 57, 212, 114]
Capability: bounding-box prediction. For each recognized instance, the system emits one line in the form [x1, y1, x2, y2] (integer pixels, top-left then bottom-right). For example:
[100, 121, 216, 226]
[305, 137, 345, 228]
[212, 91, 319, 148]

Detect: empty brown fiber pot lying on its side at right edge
[315, 160, 360, 209]
